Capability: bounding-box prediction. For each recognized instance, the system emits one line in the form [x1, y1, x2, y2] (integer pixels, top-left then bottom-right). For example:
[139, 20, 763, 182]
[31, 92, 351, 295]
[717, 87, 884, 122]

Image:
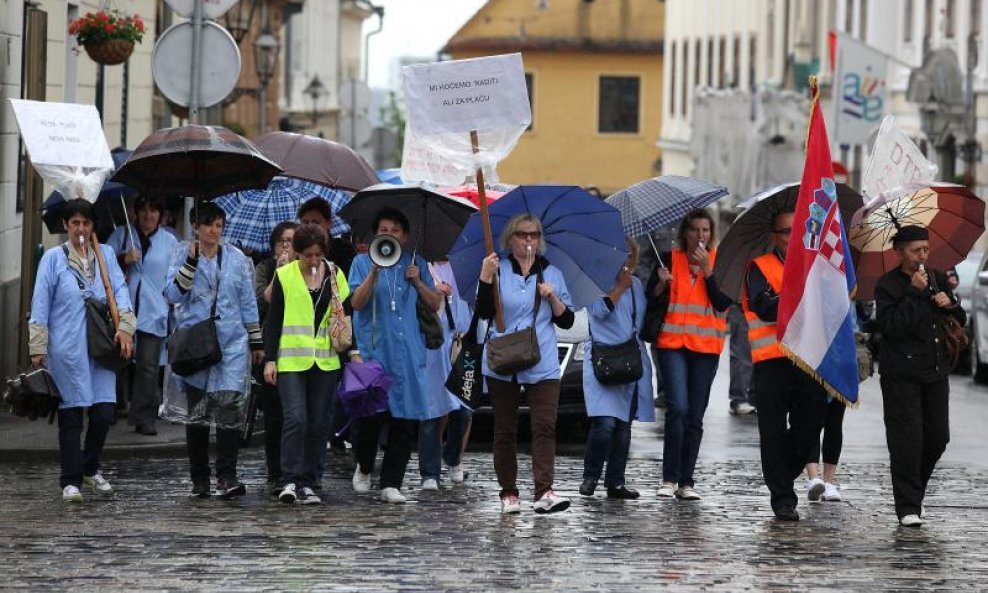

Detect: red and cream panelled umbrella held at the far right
[848, 183, 985, 300]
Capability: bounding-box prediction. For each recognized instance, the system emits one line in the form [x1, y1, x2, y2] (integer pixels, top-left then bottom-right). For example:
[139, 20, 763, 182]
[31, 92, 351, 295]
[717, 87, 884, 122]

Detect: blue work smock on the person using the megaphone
[348, 252, 457, 420]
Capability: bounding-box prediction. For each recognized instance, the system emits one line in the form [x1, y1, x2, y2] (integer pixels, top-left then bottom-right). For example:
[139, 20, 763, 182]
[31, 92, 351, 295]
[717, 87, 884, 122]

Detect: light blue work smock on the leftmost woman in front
[30, 245, 131, 408]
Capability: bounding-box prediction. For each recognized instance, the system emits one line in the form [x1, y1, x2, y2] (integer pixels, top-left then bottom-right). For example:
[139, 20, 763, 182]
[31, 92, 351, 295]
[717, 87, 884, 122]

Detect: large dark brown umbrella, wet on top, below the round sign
[113, 124, 281, 200]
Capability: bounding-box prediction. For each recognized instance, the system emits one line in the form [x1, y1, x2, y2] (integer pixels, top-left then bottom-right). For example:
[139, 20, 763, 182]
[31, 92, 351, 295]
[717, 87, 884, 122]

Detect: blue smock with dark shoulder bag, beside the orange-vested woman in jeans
[583, 278, 655, 422]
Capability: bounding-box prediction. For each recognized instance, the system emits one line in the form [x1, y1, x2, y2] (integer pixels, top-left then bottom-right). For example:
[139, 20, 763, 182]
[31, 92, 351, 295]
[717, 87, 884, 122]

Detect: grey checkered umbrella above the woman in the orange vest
[607, 175, 727, 239]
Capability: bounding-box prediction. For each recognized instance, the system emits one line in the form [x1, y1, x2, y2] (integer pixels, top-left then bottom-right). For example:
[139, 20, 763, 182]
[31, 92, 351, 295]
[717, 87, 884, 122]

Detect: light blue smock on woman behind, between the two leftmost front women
[106, 225, 178, 338]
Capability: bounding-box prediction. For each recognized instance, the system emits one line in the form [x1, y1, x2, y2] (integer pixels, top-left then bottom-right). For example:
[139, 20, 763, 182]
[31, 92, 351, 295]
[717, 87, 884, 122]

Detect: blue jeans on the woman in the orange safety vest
[658, 348, 720, 487]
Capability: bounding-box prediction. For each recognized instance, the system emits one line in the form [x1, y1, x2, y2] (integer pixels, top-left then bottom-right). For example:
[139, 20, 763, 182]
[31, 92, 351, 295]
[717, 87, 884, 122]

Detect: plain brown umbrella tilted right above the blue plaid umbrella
[255, 132, 379, 191]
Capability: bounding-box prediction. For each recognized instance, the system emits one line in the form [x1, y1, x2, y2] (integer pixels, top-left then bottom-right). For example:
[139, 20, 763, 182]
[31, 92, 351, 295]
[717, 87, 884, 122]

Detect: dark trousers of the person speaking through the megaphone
[353, 412, 418, 489]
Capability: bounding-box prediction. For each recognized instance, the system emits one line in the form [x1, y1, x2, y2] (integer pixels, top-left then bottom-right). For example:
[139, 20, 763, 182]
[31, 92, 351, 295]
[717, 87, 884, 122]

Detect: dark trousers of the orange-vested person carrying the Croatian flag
[755, 358, 827, 511]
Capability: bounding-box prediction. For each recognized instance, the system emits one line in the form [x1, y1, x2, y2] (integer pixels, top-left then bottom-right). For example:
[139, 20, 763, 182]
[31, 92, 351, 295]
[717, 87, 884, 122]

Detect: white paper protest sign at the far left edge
[10, 99, 113, 171]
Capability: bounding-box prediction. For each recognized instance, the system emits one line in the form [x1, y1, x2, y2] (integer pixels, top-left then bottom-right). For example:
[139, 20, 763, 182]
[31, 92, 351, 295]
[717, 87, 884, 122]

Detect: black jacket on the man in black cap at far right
[875, 268, 967, 383]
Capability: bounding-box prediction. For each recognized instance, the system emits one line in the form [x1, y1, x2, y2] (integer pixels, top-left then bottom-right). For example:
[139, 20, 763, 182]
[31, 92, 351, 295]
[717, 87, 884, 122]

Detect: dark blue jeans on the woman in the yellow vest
[278, 366, 339, 486]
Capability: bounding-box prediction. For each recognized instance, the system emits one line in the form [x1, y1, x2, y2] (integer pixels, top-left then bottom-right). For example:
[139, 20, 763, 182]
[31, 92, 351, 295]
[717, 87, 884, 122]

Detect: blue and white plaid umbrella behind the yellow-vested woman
[213, 177, 350, 253]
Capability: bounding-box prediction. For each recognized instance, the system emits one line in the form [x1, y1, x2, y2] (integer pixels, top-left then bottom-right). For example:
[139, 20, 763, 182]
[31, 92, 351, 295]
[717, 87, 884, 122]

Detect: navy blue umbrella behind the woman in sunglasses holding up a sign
[449, 185, 628, 309]
